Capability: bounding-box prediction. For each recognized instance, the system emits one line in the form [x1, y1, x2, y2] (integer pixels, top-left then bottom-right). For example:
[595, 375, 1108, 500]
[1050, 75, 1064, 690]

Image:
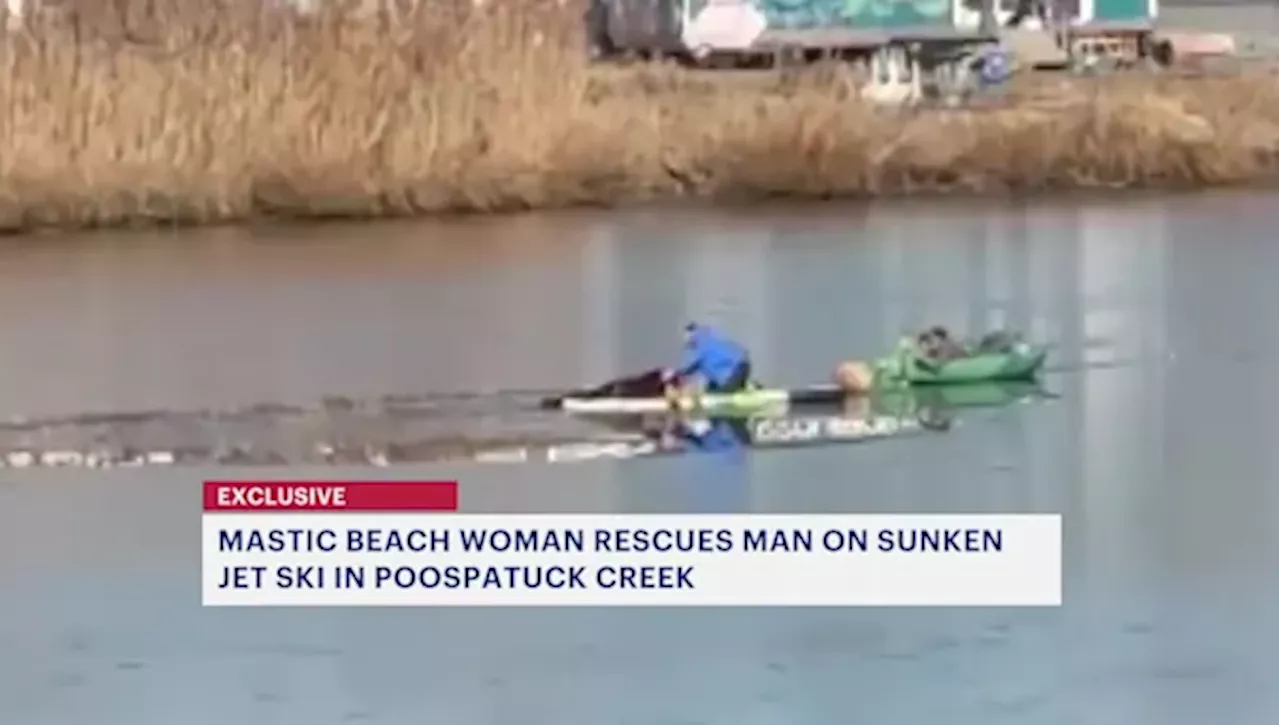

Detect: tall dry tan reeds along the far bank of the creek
[0, 0, 1280, 229]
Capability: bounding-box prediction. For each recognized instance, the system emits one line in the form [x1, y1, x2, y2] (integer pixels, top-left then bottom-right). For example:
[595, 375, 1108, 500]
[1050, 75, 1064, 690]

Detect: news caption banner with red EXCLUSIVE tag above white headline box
[202, 482, 1062, 606]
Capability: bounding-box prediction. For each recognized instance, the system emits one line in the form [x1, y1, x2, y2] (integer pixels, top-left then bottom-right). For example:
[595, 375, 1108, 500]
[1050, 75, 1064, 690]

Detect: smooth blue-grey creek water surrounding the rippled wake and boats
[0, 196, 1280, 725]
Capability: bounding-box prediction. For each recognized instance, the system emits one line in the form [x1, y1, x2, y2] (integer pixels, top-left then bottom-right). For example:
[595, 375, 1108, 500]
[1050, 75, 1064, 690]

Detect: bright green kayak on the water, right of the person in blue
[876, 338, 1048, 386]
